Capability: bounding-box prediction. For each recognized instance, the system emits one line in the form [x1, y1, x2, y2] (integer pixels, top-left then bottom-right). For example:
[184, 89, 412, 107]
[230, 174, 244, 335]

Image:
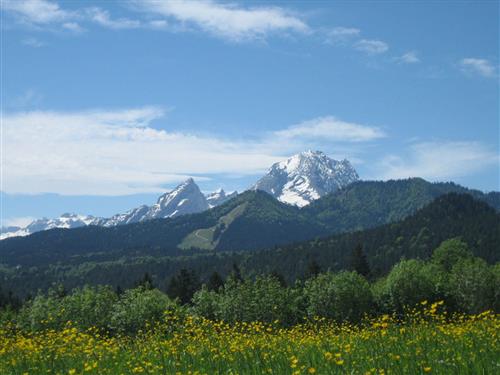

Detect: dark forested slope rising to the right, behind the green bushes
[242, 193, 500, 279]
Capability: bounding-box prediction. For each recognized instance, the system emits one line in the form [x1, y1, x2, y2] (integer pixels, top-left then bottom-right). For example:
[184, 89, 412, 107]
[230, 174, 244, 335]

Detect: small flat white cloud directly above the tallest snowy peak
[275, 116, 385, 142]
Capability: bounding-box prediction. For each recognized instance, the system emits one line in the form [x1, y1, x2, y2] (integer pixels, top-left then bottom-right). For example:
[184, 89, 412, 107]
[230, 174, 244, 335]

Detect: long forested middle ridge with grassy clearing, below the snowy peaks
[0, 178, 500, 266]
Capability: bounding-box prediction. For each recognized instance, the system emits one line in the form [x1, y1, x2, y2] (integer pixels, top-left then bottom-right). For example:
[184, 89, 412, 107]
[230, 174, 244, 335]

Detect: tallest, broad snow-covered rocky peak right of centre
[253, 151, 359, 207]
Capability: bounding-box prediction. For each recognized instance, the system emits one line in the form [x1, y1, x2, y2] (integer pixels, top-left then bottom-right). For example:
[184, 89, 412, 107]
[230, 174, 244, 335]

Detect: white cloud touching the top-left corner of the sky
[2, 0, 73, 24]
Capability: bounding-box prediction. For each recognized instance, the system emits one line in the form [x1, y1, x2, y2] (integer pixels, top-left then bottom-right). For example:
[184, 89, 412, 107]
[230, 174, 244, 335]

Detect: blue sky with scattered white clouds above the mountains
[0, 0, 500, 225]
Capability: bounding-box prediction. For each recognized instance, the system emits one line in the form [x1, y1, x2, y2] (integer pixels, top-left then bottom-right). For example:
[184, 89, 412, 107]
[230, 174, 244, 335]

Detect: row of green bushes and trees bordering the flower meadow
[0, 238, 500, 333]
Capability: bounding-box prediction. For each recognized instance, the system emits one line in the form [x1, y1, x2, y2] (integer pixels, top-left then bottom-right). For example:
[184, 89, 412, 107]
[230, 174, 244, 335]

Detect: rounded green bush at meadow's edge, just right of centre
[304, 271, 373, 321]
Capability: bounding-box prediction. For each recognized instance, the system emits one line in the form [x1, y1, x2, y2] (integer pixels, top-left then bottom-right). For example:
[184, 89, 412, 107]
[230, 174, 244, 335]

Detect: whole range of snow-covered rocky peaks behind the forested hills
[0, 151, 359, 240]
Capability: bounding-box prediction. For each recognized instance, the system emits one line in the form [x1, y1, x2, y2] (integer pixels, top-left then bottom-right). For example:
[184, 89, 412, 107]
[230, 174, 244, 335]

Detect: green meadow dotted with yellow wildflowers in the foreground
[0, 301, 500, 375]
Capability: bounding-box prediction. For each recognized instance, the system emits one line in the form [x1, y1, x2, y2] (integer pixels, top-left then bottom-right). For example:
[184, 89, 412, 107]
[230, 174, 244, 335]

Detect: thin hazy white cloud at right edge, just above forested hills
[377, 141, 499, 181]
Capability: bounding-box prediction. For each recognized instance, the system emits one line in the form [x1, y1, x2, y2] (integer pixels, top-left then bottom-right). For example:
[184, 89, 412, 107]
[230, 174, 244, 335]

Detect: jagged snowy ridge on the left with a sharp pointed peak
[0, 178, 238, 240]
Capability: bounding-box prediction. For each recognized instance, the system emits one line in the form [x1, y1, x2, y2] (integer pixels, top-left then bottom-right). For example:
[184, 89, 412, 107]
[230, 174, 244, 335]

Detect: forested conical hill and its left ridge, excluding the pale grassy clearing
[0, 191, 324, 265]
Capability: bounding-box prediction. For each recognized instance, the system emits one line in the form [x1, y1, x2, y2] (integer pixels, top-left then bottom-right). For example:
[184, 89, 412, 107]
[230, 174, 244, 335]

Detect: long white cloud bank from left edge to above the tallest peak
[0, 107, 383, 195]
